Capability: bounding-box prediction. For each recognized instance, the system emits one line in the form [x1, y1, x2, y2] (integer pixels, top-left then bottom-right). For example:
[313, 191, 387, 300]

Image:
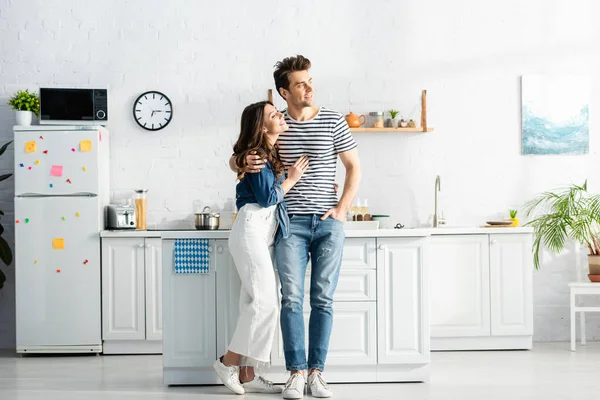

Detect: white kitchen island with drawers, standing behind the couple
[163, 233, 430, 385]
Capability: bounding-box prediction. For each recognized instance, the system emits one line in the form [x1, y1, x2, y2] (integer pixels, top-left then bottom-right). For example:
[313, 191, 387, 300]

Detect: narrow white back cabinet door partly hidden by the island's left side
[144, 238, 162, 340]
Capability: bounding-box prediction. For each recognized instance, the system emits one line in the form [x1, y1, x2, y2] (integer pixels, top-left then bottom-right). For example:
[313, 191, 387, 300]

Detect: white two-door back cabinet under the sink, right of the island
[427, 233, 533, 350]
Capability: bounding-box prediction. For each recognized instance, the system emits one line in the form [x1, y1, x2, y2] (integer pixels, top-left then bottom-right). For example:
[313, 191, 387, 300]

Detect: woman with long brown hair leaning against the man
[213, 101, 308, 394]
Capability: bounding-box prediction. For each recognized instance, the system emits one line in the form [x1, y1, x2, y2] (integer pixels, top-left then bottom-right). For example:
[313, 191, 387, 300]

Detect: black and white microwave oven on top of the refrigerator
[40, 88, 108, 125]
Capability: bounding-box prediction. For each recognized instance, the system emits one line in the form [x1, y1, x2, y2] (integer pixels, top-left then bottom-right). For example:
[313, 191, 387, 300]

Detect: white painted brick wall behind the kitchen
[0, 0, 600, 347]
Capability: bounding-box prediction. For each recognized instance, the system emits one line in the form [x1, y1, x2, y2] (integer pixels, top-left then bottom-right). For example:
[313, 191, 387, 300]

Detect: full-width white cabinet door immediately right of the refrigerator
[102, 238, 146, 340]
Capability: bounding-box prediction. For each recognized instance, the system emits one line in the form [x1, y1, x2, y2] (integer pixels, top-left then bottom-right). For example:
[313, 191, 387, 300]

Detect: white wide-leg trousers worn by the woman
[229, 204, 279, 367]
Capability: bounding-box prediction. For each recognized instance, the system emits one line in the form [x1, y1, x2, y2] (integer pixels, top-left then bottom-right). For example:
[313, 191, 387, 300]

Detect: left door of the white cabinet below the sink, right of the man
[427, 235, 490, 337]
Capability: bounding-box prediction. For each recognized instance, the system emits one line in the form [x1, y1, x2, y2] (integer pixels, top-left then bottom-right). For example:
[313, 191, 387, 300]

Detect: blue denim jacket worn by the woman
[235, 161, 290, 238]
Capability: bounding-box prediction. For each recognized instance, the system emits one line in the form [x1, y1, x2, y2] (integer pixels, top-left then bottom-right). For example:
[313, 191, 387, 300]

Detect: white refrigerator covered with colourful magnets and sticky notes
[14, 126, 109, 353]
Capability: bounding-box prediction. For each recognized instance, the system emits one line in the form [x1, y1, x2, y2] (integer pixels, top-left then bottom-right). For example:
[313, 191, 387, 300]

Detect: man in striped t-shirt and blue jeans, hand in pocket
[230, 55, 361, 399]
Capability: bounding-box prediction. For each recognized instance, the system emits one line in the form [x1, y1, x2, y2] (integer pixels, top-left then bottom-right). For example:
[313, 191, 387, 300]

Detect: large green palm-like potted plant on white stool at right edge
[525, 181, 600, 281]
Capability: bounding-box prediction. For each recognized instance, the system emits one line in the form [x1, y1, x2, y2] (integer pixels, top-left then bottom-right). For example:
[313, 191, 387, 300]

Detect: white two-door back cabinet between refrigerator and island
[102, 237, 163, 354]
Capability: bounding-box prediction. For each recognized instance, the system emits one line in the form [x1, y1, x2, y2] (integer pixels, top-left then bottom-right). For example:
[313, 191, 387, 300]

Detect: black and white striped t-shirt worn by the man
[277, 107, 356, 214]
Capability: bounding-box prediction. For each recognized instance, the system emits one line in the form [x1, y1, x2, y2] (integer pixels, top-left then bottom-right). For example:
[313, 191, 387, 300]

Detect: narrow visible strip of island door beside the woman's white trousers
[213, 240, 243, 356]
